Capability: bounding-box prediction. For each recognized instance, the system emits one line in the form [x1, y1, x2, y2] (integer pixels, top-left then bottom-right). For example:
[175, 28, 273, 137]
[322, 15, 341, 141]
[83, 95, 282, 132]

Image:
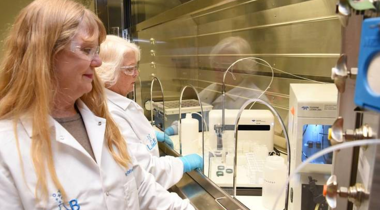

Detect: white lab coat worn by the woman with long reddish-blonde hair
[0, 101, 194, 210]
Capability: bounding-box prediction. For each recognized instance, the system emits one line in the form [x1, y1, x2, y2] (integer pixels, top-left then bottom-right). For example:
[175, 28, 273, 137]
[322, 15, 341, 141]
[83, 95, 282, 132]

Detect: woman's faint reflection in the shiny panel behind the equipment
[200, 37, 267, 109]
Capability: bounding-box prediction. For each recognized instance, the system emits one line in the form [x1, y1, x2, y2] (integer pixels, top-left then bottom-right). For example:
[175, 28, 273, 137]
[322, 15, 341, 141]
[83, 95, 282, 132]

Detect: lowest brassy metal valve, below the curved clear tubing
[323, 175, 369, 209]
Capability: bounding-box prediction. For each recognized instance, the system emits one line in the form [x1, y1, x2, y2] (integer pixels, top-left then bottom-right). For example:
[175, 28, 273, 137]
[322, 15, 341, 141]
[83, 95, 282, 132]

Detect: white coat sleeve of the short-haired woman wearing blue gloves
[113, 113, 183, 189]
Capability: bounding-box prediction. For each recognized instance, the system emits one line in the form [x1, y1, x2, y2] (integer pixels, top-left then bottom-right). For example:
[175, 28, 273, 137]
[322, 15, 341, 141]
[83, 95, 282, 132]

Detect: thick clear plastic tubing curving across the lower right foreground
[272, 139, 380, 210]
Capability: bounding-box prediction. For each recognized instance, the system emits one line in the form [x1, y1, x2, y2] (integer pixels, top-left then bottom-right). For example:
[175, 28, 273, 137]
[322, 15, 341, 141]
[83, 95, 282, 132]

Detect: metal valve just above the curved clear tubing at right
[328, 117, 376, 145]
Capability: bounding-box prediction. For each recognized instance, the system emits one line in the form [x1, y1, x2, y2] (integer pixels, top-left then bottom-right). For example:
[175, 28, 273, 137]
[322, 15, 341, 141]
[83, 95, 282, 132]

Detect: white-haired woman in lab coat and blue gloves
[96, 35, 203, 189]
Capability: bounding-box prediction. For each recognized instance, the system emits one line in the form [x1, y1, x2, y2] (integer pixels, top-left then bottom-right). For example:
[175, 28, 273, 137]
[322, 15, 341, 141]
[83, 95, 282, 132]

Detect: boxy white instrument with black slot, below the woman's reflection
[207, 109, 274, 187]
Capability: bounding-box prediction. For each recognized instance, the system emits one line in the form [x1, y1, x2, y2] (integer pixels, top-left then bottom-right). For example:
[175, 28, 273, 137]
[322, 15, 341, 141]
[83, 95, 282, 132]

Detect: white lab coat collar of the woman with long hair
[20, 100, 106, 163]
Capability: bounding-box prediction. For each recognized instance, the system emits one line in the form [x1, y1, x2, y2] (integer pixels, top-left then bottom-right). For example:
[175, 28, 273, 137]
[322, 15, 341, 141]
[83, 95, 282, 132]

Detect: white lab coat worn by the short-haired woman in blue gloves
[106, 90, 183, 189]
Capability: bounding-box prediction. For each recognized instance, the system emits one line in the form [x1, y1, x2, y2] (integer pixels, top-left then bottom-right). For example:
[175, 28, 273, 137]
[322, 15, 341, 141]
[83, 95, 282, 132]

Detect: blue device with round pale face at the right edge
[355, 18, 380, 112]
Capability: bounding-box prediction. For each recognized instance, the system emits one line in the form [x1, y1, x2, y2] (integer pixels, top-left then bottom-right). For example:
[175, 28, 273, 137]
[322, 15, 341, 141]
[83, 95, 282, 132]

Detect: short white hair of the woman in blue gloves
[96, 35, 141, 87]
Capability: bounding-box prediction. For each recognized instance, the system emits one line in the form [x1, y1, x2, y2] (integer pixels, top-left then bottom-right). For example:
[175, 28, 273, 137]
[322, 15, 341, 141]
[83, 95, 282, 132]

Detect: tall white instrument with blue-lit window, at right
[288, 84, 338, 210]
